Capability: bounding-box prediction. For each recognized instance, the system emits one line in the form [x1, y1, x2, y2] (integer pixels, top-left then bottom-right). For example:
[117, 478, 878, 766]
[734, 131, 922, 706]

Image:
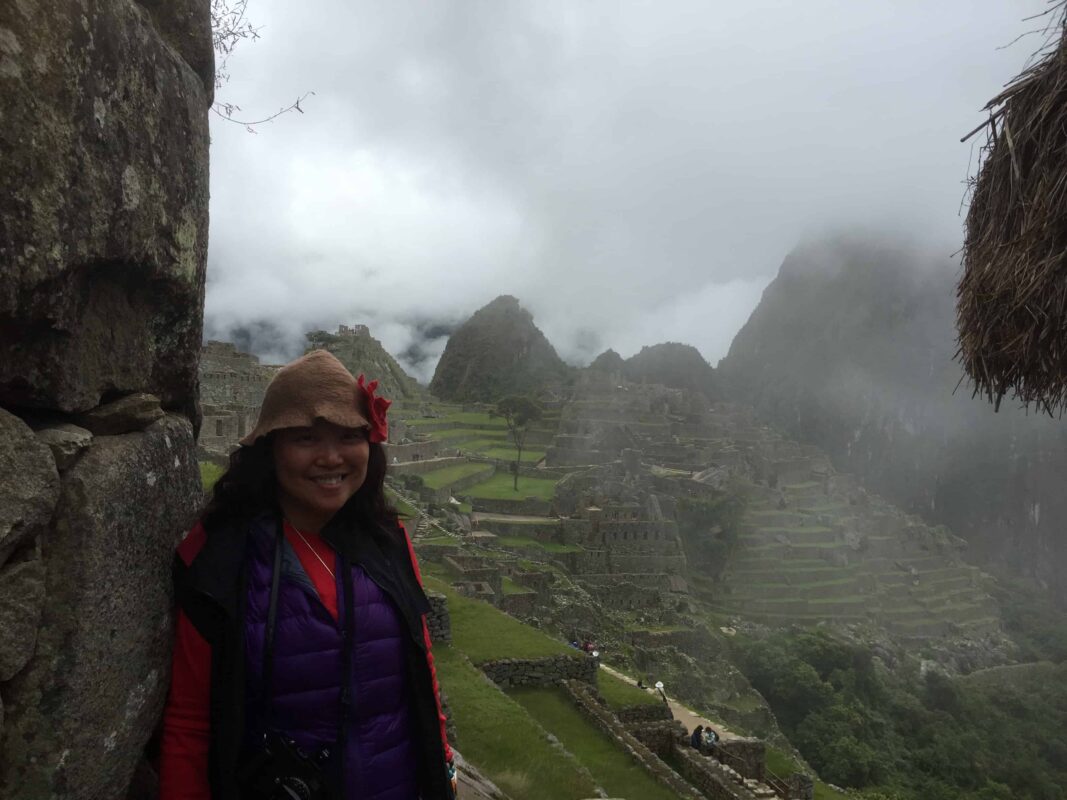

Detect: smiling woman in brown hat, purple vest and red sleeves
[160, 350, 456, 800]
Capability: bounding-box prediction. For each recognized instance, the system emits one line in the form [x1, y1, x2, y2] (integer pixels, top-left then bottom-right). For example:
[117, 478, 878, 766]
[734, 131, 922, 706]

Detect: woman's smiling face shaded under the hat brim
[273, 419, 370, 531]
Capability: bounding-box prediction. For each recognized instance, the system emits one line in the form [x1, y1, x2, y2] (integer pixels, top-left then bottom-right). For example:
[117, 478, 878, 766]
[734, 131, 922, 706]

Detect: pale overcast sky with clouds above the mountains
[206, 0, 1047, 380]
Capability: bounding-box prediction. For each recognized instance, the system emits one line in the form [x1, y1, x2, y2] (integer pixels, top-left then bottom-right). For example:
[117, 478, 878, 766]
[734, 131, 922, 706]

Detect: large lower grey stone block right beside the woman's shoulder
[0, 416, 202, 800]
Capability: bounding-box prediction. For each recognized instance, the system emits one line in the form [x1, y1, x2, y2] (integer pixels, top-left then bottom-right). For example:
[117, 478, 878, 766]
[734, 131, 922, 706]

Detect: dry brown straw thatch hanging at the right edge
[956, 6, 1067, 414]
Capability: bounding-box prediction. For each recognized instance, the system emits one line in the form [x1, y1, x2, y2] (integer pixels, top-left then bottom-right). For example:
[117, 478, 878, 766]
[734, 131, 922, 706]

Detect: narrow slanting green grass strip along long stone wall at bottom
[510, 688, 678, 800]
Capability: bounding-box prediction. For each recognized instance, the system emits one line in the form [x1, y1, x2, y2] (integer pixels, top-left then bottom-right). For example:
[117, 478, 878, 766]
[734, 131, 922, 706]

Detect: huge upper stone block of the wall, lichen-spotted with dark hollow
[0, 0, 212, 416]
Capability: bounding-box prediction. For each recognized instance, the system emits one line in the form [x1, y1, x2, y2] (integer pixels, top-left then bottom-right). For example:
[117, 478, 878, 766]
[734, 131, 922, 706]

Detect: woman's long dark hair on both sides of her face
[201, 433, 397, 539]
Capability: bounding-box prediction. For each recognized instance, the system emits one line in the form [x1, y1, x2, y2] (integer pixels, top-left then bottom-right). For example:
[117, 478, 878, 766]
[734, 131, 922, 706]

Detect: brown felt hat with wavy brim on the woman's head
[241, 350, 370, 445]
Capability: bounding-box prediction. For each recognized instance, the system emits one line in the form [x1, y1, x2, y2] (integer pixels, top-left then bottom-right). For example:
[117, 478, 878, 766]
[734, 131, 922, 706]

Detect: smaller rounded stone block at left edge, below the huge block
[0, 409, 60, 564]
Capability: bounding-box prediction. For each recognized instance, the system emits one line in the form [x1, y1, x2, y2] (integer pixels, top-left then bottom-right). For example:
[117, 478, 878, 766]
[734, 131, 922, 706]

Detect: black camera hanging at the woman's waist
[239, 732, 337, 800]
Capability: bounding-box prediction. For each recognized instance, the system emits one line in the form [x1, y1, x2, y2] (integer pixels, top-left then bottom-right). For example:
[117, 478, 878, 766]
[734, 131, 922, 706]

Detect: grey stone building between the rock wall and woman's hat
[196, 341, 278, 461]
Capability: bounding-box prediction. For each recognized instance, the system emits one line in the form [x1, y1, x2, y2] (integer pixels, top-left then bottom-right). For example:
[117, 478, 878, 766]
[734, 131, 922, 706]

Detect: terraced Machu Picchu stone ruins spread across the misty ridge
[181, 292, 1049, 798]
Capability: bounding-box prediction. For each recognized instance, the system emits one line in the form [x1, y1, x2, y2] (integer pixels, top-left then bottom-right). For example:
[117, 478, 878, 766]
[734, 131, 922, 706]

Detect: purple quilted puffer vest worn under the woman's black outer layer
[244, 523, 418, 800]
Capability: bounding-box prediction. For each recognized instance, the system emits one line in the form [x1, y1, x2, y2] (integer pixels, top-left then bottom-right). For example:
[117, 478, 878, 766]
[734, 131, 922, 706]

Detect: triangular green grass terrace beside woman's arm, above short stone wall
[427, 577, 578, 663]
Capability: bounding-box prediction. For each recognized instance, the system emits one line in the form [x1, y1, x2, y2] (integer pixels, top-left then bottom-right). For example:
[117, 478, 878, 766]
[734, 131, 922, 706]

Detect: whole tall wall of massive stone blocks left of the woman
[0, 0, 214, 800]
